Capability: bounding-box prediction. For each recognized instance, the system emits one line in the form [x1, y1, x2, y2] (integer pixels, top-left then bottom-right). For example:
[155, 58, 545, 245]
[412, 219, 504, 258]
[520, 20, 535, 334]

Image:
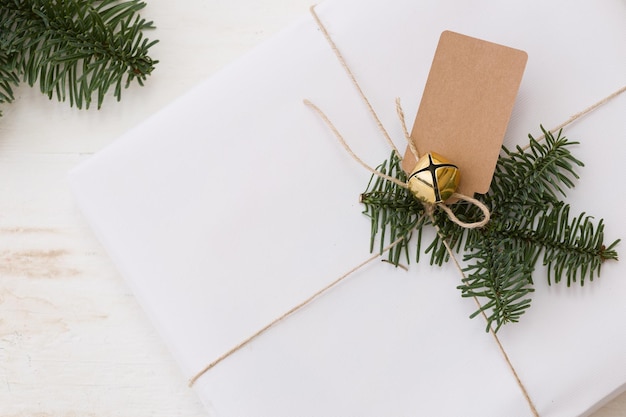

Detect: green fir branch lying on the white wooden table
[0, 0, 157, 112]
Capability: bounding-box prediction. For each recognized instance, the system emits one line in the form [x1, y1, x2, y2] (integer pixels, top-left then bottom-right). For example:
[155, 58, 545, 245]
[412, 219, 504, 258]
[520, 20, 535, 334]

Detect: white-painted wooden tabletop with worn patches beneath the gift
[0, 0, 626, 417]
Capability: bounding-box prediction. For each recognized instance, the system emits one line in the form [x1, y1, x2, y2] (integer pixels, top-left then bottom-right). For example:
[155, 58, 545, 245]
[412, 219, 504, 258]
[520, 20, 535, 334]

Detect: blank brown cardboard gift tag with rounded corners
[402, 31, 527, 196]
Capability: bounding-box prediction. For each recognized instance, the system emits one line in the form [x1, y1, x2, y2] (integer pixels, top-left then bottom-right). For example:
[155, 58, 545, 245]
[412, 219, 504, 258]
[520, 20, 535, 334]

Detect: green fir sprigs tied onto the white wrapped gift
[362, 127, 619, 331]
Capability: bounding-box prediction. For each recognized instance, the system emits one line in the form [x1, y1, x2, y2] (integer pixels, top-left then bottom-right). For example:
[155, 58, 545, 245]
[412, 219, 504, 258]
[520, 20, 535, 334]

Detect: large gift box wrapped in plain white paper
[70, 0, 626, 417]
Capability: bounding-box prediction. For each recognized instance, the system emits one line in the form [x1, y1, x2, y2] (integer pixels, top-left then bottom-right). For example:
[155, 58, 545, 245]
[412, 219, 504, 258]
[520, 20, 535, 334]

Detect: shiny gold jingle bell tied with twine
[408, 152, 461, 204]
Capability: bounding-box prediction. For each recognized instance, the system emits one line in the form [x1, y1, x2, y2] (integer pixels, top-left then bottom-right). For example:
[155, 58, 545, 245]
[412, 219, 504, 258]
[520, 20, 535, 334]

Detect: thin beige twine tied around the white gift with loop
[189, 6, 626, 417]
